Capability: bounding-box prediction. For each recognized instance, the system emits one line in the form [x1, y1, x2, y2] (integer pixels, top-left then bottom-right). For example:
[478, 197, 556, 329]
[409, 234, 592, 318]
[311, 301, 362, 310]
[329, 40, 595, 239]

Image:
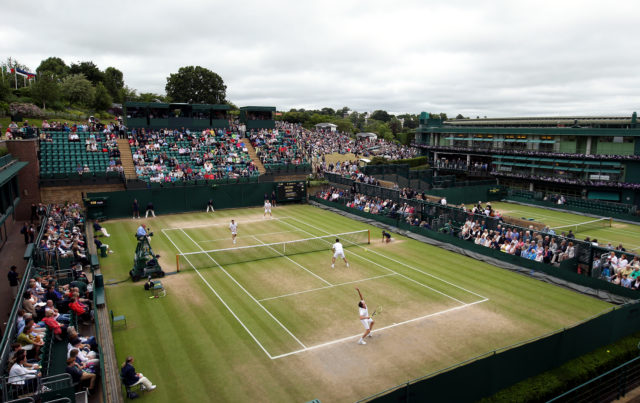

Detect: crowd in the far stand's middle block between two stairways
[129, 129, 258, 182]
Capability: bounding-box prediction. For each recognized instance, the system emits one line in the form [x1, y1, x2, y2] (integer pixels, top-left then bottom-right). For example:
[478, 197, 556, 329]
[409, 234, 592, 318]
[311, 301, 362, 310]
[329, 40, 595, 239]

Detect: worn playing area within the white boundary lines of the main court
[162, 217, 488, 359]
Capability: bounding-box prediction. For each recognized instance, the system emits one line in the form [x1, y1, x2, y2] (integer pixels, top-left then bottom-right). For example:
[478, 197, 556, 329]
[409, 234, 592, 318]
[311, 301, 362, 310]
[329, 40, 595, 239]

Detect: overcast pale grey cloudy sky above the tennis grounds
[0, 0, 640, 117]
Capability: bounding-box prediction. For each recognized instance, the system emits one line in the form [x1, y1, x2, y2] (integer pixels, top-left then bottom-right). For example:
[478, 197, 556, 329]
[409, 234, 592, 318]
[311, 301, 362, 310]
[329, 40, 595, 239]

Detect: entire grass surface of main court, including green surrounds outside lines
[101, 205, 610, 402]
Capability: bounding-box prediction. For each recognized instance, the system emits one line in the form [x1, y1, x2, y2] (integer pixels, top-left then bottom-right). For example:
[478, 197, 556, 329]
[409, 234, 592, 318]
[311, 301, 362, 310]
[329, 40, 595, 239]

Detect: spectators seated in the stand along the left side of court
[7, 204, 99, 396]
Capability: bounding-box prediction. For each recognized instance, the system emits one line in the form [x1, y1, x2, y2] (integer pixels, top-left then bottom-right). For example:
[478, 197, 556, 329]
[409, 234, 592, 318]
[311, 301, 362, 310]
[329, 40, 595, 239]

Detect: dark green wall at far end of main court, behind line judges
[87, 182, 282, 218]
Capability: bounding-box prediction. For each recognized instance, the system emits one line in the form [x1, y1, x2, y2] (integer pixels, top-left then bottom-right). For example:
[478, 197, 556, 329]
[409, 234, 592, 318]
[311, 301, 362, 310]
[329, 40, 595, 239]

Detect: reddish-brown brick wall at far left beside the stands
[5, 139, 40, 221]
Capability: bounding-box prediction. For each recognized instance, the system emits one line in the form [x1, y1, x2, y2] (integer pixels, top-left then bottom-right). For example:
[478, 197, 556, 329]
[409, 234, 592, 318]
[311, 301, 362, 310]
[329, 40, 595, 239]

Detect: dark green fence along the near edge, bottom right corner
[363, 303, 640, 403]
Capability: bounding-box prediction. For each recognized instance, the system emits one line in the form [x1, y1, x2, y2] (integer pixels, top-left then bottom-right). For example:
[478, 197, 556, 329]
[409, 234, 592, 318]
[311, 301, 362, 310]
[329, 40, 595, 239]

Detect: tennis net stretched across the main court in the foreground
[176, 230, 371, 271]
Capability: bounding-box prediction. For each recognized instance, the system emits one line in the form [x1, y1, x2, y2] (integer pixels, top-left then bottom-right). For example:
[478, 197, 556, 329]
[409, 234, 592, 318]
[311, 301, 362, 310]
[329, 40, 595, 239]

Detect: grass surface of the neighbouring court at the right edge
[484, 202, 640, 253]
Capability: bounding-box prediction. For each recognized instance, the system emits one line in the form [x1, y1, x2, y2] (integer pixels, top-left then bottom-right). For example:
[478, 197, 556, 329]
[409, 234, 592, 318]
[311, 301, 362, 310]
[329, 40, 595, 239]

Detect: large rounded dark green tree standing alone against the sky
[165, 66, 227, 104]
